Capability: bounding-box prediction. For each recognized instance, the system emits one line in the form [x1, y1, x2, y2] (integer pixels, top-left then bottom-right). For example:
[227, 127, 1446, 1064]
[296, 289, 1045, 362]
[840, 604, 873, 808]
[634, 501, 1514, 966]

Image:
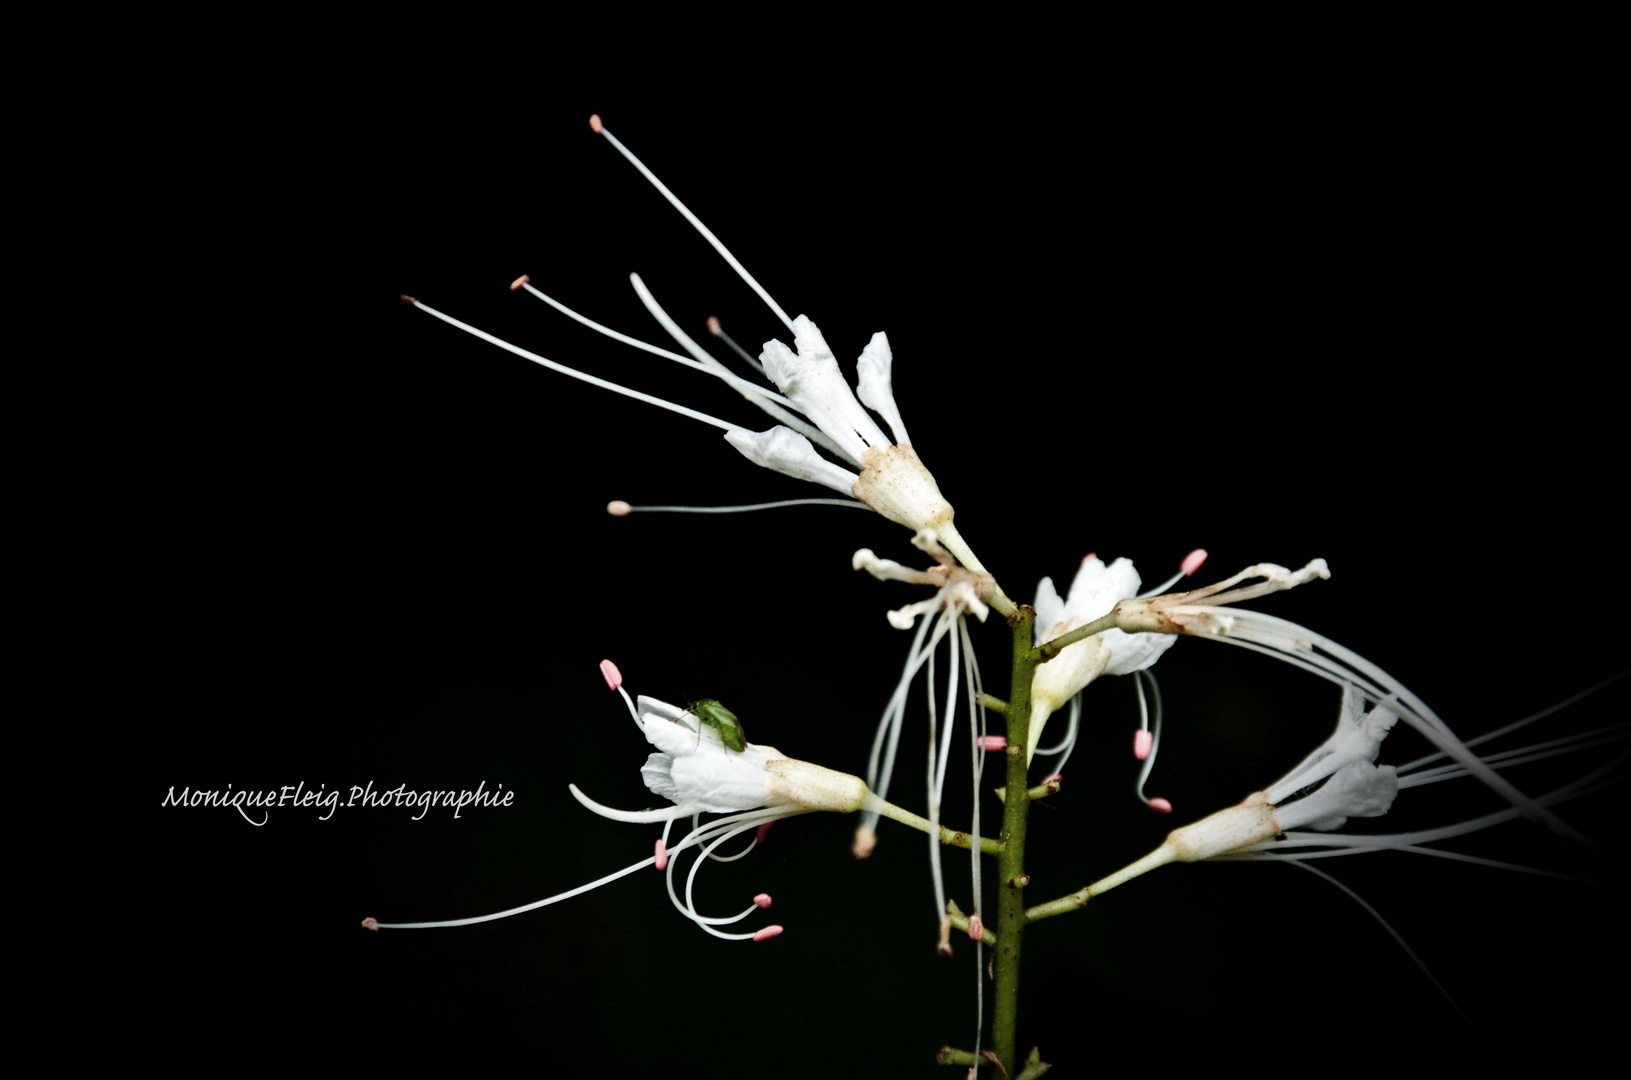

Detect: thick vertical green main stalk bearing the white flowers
[992, 605, 1037, 1075]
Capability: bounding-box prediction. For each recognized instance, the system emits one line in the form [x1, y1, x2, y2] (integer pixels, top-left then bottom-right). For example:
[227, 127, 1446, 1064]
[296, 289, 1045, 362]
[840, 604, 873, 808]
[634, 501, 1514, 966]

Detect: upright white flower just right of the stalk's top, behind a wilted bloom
[1028, 555, 1174, 760]
